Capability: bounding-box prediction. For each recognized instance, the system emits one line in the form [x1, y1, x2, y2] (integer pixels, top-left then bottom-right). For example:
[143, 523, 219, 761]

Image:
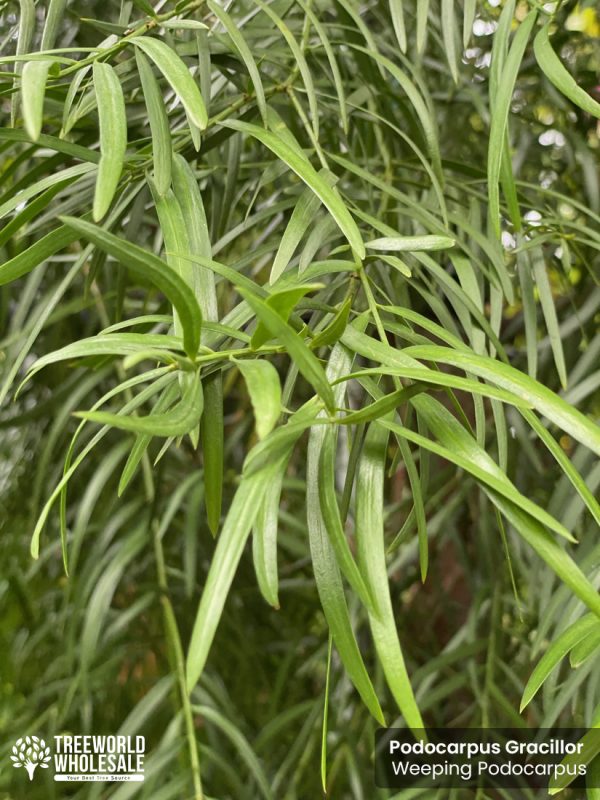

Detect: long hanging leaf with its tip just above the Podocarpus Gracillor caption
[356, 418, 424, 730]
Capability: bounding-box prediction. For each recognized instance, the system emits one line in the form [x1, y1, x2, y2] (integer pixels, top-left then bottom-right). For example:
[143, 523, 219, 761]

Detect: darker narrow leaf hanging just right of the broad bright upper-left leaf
[135, 50, 173, 195]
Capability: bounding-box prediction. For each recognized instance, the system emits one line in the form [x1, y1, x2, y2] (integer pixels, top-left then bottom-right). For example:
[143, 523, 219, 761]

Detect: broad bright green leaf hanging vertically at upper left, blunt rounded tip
[92, 61, 127, 222]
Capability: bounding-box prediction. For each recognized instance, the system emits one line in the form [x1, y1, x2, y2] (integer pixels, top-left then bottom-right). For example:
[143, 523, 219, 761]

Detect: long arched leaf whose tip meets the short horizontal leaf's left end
[221, 120, 365, 259]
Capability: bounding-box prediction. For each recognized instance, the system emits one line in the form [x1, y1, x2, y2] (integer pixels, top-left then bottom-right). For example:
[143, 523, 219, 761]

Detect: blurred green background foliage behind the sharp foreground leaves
[0, 0, 600, 800]
